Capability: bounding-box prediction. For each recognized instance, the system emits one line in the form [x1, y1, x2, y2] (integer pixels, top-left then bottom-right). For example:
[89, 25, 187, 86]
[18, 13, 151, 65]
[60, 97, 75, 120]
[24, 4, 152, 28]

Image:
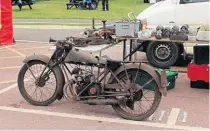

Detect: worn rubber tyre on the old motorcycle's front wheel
[18, 60, 62, 106]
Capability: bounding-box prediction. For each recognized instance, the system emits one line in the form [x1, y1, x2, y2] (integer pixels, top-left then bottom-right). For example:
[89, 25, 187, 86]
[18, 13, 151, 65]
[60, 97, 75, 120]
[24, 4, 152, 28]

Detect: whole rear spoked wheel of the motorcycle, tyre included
[110, 69, 161, 121]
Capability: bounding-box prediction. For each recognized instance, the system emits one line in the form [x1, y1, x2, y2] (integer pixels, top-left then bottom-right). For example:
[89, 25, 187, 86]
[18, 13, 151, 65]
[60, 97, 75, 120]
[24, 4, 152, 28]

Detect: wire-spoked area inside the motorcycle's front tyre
[23, 64, 57, 103]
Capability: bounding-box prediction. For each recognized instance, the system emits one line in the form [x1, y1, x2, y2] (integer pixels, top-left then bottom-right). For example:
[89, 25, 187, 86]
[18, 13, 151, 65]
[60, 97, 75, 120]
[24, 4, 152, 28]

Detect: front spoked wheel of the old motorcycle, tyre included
[18, 60, 61, 106]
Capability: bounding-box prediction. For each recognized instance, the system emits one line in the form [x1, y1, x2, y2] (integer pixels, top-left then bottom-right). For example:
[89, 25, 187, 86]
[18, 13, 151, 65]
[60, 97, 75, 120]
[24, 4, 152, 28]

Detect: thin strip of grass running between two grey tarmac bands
[13, 22, 102, 26]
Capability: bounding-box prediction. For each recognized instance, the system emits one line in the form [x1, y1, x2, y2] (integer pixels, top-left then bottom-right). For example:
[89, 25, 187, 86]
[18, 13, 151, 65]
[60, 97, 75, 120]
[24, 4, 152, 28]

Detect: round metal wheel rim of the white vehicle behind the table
[155, 44, 172, 61]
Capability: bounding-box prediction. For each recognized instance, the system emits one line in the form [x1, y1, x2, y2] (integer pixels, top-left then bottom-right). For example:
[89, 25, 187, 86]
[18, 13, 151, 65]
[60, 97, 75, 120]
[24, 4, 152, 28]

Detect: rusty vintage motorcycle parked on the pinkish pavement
[18, 37, 168, 120]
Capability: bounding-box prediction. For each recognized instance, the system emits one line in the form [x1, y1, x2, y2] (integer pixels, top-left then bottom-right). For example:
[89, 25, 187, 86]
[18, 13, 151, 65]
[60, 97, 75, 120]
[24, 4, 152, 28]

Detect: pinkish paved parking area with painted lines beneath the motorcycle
[0, 43, 209, 130]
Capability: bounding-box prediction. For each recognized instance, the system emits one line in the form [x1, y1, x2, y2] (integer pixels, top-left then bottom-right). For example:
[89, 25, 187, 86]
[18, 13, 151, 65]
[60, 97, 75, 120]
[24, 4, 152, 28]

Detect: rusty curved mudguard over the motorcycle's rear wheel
[108, 63, 168, 96]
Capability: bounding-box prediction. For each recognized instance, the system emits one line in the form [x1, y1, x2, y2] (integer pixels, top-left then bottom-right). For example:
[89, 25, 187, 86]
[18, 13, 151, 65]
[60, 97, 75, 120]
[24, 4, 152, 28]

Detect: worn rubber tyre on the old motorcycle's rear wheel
[112, 69, 162, 121]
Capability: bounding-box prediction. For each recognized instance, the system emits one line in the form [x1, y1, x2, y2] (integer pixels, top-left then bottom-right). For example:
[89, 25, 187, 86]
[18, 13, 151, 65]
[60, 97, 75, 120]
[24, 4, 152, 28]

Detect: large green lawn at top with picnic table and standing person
[13, 0, 150, 19]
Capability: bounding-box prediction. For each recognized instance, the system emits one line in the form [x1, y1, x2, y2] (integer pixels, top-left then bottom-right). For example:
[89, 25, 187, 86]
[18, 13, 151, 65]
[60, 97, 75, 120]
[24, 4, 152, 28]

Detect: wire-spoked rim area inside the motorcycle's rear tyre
[114, 69, 158, 116]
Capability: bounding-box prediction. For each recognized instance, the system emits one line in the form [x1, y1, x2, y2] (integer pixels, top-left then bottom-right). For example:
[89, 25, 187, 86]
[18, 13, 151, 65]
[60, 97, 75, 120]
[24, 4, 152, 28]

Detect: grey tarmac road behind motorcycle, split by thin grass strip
[13, 19, 115, 42]
